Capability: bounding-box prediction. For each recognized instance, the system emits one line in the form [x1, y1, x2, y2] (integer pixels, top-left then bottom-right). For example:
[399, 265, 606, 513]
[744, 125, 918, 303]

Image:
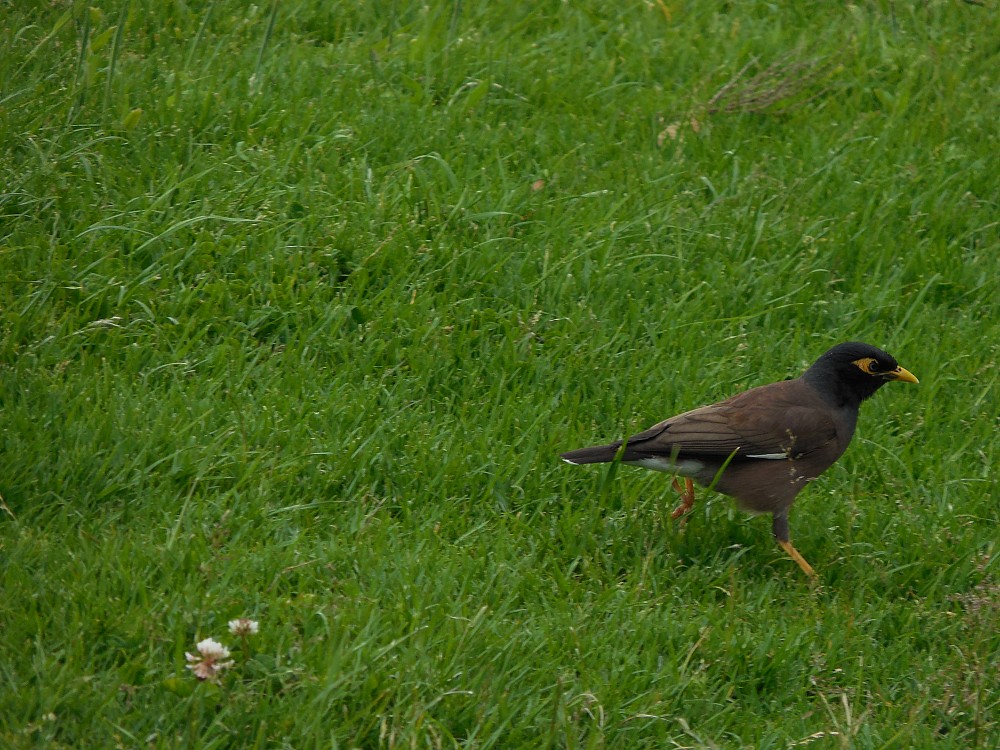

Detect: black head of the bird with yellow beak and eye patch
[802, 341, 917, 406]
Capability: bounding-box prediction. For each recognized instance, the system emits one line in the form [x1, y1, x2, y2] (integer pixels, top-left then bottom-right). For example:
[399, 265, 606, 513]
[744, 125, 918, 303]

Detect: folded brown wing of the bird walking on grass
[623, 380, 837, 460]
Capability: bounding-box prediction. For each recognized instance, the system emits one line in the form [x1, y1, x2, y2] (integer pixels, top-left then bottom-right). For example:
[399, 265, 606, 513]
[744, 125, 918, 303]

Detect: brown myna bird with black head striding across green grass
[561, 341, 919, 578]
